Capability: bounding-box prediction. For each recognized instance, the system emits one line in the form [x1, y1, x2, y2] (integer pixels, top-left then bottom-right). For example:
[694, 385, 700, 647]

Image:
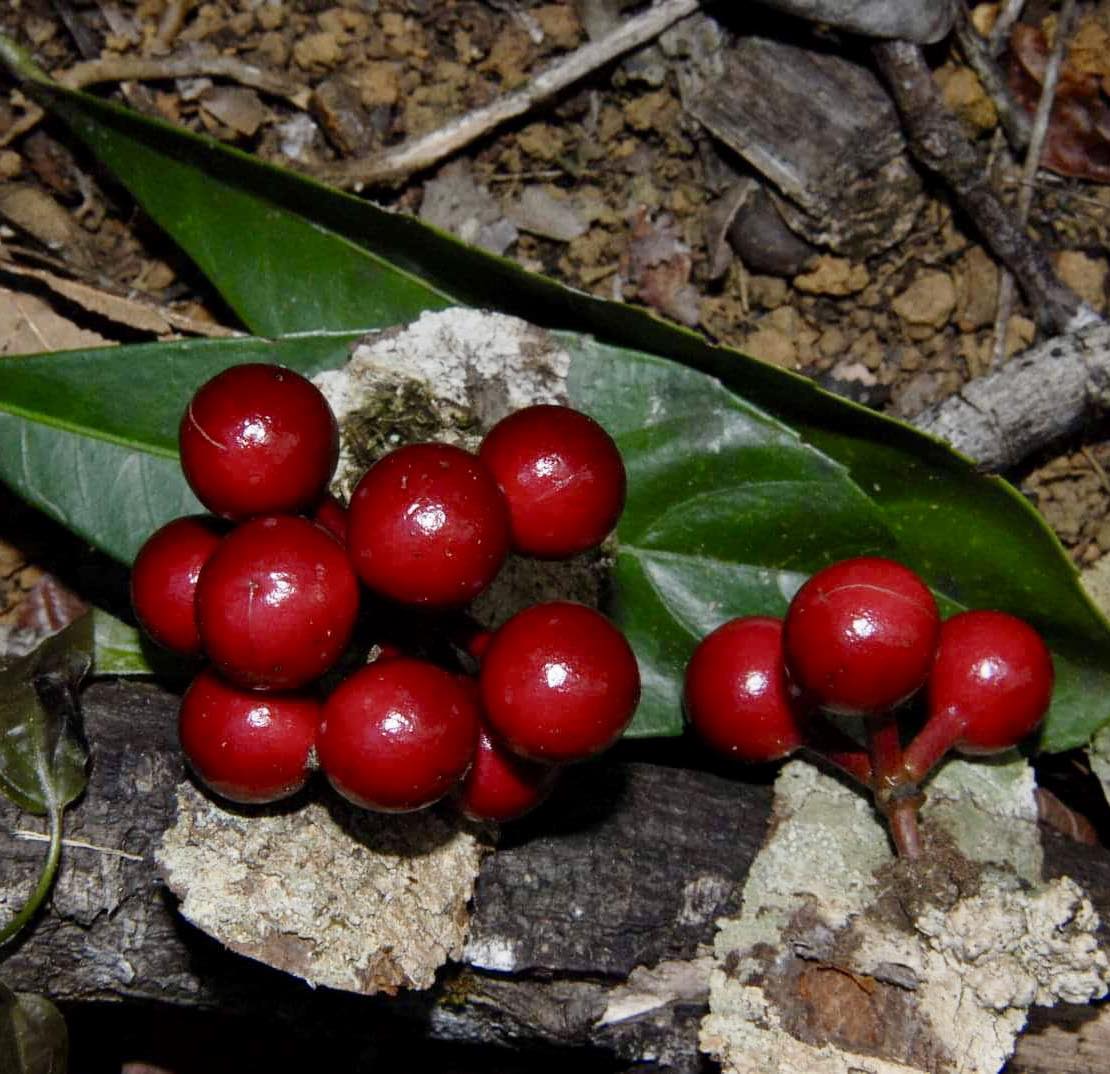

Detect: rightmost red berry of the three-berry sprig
[929, 611, 1053, 753]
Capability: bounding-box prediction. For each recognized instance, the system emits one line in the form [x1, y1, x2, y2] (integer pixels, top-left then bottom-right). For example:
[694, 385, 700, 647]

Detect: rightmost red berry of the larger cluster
[480, 600, 639, 763]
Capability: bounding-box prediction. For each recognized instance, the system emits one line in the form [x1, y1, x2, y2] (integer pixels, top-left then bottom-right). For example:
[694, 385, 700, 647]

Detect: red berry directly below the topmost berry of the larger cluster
[196, 515, 359, 690]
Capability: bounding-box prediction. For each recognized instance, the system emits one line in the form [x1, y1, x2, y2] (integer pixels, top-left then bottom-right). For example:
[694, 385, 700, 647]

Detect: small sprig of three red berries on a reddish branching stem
[685, 557, 1053, 857]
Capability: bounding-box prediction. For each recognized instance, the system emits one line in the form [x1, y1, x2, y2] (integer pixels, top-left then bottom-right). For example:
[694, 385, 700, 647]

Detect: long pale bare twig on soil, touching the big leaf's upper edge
[313, 0, 699, 191]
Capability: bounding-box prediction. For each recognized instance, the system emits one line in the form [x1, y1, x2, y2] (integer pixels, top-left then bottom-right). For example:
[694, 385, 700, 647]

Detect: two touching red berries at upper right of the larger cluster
[347, 406, 625, 607]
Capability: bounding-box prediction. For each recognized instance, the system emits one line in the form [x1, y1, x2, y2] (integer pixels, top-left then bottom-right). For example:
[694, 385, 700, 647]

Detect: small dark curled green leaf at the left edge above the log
[0, 616, 92, 814]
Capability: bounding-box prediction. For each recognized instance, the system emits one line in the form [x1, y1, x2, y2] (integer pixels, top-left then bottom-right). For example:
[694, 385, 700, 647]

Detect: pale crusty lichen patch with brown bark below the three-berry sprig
[702, 759, 1110, 1074]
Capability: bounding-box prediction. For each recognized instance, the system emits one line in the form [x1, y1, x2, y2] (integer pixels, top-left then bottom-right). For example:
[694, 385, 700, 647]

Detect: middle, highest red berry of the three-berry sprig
[783, 556, 940, 716]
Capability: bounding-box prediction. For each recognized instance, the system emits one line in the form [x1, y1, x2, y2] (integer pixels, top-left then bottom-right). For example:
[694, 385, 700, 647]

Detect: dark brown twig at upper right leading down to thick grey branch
[872, 41, 1098, 334]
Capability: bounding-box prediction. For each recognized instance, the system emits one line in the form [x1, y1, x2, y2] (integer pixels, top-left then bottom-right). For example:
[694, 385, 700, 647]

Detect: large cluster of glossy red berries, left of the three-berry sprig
[131, 364, 639, 820]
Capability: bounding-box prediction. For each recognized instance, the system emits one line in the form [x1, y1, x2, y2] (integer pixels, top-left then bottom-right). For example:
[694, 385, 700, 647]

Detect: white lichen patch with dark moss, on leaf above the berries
[314, 308, 571, 496]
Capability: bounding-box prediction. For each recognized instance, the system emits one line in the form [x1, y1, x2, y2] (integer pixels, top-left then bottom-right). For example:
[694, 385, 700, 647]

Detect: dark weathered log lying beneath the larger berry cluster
[0, 683, 1110, 1072]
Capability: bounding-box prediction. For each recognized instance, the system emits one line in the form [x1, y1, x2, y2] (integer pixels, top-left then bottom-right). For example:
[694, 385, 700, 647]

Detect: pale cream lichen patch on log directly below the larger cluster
[157, 783, 483, 994]
